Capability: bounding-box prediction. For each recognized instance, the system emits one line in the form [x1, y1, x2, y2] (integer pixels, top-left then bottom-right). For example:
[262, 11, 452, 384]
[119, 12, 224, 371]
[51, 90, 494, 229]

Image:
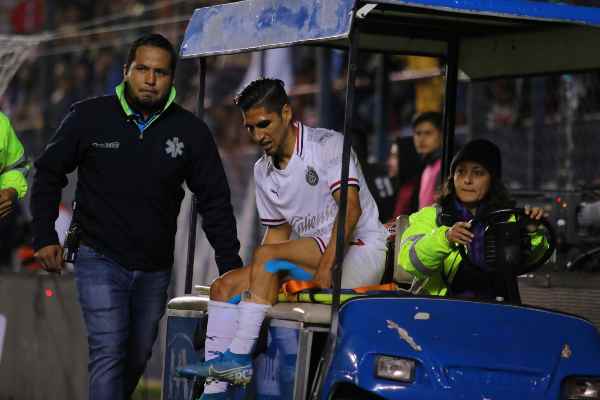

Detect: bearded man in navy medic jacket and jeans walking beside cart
[31, 34, 242, 400]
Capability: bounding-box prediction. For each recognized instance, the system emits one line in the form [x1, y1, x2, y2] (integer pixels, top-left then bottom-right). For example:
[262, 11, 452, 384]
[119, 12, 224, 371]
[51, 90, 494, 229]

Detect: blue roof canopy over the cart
[181, 0, 600, 79]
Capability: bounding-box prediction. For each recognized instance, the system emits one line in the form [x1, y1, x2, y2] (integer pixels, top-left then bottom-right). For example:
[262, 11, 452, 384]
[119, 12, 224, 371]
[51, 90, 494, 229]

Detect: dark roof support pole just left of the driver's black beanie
[440, 37, 459, 181]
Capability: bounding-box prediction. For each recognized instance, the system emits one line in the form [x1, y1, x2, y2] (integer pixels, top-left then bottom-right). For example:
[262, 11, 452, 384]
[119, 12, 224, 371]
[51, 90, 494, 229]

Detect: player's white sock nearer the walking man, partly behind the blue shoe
[204, 300, 239, 393]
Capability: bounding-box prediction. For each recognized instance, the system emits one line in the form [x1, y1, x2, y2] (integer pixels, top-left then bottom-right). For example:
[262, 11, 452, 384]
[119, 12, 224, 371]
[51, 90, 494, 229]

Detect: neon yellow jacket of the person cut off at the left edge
[0, 112, 30, 199]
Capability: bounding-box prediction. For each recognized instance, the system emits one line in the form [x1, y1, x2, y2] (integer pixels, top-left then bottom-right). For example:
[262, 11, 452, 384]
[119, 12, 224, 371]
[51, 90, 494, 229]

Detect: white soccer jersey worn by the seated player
[254, 123, 387, 252]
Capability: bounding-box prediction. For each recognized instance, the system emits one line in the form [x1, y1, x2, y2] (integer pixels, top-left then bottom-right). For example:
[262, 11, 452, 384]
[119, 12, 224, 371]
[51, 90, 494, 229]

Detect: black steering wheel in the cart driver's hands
[459, 208, 556, 275]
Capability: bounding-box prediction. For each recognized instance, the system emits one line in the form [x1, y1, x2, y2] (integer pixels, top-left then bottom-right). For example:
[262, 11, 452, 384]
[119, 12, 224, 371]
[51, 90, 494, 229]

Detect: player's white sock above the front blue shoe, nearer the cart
[229, 301, 271, 354]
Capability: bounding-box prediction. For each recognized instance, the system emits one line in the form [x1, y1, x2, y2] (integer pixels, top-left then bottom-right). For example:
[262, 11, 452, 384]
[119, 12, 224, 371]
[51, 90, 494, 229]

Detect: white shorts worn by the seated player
[342, 244, 387, 289]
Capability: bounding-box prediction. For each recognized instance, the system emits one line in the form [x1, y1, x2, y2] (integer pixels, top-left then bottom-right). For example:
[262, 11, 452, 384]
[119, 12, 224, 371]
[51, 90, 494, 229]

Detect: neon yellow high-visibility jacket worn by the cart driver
[396, 206, 548, 296]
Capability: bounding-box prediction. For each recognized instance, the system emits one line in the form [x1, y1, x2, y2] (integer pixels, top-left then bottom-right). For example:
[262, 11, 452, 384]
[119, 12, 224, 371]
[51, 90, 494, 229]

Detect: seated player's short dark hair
[234, 78, 290, 112]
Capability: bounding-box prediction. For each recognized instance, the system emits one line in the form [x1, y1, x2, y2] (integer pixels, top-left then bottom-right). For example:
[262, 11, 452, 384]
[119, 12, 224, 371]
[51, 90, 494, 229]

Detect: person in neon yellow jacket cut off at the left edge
[0, 112, 30, 219]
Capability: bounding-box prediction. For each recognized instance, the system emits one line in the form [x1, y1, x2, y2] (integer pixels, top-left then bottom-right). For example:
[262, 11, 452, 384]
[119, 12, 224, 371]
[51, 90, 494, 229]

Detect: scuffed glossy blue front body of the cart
[323, 297, 600, 399]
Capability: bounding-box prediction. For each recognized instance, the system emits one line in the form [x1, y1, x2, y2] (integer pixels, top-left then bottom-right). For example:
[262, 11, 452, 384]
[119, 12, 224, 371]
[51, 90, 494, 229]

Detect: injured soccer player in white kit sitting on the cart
[179, 78, 387, 399]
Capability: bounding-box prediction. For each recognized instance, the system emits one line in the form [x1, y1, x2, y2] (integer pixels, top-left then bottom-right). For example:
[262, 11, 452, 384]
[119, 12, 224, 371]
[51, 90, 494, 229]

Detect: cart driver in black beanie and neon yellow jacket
[396, 139, 548, 298]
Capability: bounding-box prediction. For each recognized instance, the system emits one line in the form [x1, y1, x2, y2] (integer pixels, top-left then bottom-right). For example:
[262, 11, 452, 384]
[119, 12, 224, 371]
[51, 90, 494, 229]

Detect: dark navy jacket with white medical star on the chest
[31, 95, 242, 273]
